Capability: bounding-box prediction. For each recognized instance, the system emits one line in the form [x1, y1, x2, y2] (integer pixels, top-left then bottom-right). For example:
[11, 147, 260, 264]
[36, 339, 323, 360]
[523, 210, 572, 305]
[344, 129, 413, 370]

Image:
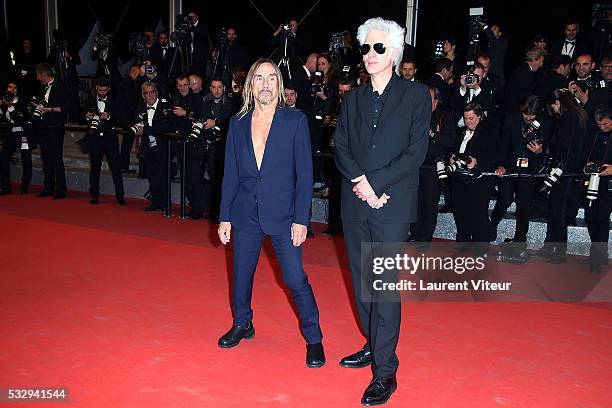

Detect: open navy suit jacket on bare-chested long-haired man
[220, 107, 313, 235]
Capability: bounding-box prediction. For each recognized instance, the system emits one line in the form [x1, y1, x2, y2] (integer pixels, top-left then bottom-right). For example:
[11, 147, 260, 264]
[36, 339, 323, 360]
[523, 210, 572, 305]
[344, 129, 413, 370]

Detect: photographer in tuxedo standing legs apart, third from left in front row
[82, 76, 125, 205]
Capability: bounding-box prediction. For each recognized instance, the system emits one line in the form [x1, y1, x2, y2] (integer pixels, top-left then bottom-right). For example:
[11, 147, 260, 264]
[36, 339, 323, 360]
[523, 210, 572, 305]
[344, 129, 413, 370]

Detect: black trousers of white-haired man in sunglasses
[343, 219, 410, 377]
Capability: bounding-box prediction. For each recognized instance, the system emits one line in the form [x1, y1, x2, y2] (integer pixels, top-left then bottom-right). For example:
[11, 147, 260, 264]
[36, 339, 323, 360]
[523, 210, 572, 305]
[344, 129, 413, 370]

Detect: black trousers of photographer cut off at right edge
[585, 182, 612, 265]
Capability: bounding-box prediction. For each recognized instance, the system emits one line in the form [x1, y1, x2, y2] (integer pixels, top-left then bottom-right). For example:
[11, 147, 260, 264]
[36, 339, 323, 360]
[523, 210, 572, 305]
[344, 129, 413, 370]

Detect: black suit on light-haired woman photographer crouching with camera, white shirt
[451, 121, 499, 243]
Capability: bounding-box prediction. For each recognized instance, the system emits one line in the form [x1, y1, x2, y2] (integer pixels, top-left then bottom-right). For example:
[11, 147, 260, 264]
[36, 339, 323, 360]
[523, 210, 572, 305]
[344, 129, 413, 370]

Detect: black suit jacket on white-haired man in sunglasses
[335, 74, 431, 223]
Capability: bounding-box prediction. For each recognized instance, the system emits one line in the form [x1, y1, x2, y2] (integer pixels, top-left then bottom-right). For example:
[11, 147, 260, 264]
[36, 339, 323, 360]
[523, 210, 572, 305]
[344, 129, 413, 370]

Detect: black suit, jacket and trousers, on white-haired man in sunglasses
[335, 75, 431, 377]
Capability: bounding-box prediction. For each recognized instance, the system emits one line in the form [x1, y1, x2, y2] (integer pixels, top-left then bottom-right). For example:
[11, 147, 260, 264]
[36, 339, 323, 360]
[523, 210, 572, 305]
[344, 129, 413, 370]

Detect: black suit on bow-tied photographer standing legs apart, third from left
[84, 96, 124, 198]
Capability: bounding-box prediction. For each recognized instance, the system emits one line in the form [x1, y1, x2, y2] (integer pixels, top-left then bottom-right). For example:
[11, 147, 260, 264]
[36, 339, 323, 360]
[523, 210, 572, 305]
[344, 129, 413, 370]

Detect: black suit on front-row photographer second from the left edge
[36, 79, 70, 195]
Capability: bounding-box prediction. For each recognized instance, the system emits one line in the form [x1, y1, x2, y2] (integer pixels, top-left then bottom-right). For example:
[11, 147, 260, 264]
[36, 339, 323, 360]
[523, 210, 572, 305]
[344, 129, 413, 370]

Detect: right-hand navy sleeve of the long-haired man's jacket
[294, 115, 313, 225]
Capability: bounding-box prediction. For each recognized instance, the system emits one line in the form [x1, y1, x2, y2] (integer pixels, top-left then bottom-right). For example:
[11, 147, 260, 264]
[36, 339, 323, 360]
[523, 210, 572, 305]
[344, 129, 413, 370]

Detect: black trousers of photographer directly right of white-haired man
[410, 168, 440, 242]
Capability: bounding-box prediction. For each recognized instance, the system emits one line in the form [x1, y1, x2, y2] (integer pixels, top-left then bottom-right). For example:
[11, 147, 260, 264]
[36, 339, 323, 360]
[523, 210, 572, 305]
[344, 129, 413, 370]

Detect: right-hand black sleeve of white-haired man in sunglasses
[366, 87, 431, 197]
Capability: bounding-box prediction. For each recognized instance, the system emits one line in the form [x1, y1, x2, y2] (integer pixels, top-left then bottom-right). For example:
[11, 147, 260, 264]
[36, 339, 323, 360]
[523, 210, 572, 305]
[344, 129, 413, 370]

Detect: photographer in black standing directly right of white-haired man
[410, 86, 457, 242]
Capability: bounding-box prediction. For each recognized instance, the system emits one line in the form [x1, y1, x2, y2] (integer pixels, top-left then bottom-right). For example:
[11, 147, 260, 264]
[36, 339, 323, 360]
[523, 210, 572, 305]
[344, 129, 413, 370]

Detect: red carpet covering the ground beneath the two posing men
[0, 193, 612, 408]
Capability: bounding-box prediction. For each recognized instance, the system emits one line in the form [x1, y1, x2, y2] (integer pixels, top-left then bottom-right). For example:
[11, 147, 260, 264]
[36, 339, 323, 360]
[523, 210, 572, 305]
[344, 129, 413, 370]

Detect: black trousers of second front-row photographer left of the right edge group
[491, 177, 536, 242]
